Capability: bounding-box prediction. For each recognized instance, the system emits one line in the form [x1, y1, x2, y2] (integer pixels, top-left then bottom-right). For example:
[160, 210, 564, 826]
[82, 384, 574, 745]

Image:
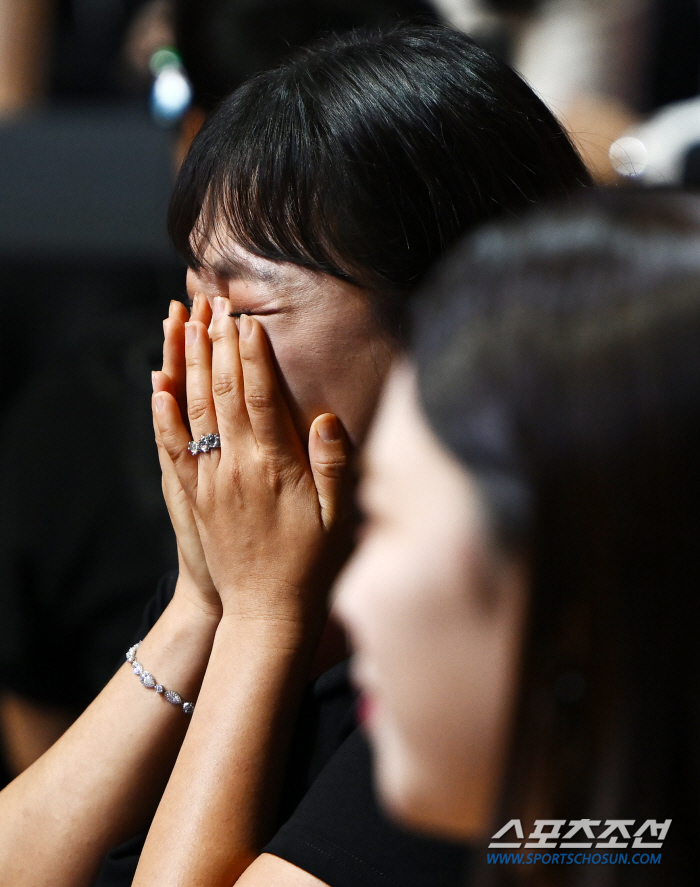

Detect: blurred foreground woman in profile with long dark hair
[339, 194, 700, 885]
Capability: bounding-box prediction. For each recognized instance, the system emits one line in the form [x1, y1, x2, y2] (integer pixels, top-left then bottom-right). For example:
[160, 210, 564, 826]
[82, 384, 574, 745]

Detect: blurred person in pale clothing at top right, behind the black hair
[438, 0, 649, 182]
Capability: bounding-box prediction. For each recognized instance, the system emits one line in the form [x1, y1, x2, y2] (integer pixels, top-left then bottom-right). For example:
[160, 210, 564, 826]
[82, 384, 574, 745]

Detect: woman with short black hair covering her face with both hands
[0, 20, 588, 887]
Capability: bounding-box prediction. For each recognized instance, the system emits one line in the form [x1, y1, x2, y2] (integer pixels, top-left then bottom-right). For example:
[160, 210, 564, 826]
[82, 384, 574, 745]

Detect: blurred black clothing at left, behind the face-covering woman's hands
[0, 312, 176, 714]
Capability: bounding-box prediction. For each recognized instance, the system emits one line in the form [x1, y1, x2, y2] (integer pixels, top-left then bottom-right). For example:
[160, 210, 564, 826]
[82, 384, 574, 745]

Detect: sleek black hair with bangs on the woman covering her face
[169, 25, 590, 332]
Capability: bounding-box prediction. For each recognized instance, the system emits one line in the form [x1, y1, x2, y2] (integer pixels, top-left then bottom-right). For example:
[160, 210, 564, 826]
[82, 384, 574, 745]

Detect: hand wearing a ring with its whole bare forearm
[134, 300, 347, 887]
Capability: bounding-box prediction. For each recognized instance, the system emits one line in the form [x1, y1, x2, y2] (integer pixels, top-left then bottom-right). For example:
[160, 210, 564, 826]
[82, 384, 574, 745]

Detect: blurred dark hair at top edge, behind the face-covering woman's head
[175, 0, 438, 112]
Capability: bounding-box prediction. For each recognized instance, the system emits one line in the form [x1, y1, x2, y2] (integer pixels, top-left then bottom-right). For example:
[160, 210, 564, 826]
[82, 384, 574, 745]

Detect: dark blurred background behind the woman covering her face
[0, 0, 700, 784]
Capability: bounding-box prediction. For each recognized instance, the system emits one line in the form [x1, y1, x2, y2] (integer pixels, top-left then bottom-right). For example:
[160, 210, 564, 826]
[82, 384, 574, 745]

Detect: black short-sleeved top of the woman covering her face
[94, 573, 467, 887]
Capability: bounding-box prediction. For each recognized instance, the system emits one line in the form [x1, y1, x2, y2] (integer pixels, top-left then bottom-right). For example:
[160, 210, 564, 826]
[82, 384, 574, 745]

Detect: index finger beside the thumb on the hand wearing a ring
[238, 314, 303, 460]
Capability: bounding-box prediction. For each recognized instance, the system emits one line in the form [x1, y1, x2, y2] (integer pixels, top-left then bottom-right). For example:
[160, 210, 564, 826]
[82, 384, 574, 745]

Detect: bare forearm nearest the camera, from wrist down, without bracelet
[134, 617, 320, 887]
